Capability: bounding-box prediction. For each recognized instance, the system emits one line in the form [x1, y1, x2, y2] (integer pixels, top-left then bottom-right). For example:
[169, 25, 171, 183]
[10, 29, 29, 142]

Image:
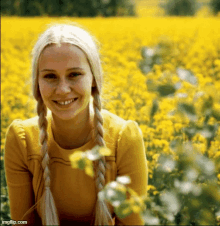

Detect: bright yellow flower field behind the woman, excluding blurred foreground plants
[1, 17, 220, 224]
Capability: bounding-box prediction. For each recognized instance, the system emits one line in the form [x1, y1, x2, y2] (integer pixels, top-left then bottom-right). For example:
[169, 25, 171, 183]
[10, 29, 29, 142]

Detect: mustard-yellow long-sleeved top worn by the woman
[5, 110, 148, 226]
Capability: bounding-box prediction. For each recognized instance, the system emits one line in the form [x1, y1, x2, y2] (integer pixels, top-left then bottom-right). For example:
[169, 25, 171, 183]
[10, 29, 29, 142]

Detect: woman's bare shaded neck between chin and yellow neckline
[51, 106, 93, 149]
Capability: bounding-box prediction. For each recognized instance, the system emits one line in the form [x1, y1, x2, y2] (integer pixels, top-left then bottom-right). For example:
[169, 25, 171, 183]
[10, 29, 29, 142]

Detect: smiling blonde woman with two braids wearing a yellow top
[5, 25, 147, 225]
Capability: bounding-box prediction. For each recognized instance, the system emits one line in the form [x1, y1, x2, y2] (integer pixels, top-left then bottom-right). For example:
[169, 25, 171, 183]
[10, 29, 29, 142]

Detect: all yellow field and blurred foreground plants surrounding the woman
[1, 17, 220, 225]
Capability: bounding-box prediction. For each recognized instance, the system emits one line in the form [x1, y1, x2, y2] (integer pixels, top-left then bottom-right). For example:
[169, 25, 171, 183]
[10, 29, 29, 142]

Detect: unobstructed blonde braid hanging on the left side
[37, 97, 59, 225]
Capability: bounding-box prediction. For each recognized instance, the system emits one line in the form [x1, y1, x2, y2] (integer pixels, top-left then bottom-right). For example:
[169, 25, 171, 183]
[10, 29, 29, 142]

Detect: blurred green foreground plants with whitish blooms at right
[71, 36, 220, 226]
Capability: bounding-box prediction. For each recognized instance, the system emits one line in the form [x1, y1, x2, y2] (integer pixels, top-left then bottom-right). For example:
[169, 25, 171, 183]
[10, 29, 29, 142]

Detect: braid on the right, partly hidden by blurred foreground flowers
[93, 88, 112, 225]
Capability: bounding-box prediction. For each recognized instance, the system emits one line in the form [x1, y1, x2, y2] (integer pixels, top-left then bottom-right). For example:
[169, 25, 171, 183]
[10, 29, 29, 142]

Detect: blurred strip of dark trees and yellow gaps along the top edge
[1, 0, 220, 17]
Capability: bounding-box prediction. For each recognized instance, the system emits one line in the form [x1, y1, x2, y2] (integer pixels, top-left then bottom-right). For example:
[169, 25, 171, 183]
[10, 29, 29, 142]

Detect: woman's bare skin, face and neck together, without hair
[38, 43, 95, 148]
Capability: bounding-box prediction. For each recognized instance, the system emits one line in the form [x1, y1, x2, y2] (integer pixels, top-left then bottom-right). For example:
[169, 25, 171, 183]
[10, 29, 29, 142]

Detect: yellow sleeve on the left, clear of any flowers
[4, 120, 41, 225]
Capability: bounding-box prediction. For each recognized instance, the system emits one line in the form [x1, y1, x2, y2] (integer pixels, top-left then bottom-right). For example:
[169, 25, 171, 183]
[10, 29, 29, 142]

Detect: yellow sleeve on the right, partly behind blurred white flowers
[115, 120, 148, 225]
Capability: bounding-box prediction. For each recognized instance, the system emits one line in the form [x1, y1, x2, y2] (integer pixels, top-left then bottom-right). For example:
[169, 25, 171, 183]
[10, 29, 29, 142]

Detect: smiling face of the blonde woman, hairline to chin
[38, 43, 94, 120]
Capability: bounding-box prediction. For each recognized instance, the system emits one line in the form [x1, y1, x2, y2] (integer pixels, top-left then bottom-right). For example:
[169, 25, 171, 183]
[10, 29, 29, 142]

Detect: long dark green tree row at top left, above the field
[1, 0, 135, 17]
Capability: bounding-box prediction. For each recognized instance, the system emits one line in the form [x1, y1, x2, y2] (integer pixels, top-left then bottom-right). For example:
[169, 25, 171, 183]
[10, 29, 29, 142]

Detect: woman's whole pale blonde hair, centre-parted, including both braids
[25, 24, 112, 225]
